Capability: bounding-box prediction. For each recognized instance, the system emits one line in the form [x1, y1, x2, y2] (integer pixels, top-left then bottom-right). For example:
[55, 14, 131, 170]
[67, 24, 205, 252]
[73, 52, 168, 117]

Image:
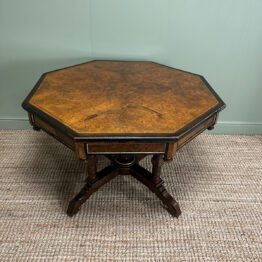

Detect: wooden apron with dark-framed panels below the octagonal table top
[29, 113, 218, 160]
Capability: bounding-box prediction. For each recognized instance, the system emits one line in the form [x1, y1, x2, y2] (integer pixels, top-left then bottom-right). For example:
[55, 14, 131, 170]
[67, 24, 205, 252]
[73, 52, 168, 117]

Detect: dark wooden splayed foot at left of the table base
[67, 163, 118, 216]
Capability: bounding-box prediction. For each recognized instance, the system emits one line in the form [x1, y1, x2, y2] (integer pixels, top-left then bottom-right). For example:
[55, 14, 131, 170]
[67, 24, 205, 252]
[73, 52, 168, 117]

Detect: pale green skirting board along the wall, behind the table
[0, 118, 262, 135]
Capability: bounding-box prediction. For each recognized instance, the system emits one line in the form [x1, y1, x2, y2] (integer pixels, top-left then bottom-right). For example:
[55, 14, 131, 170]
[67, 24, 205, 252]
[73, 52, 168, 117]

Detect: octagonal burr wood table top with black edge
[23, 61, 225, 140]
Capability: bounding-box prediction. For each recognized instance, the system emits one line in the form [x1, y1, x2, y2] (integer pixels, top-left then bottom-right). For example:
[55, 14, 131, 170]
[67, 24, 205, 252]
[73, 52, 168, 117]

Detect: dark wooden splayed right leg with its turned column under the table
[130, 156, 181, 217]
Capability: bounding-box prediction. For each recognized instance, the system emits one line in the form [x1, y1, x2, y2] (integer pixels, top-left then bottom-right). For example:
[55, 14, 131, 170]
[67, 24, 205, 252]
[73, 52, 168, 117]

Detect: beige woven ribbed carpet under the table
[0, 131, 262, 261]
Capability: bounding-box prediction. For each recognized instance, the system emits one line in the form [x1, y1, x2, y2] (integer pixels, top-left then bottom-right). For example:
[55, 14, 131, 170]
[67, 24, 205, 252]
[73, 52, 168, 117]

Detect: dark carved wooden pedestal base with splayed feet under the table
[67, 155, 181, 217]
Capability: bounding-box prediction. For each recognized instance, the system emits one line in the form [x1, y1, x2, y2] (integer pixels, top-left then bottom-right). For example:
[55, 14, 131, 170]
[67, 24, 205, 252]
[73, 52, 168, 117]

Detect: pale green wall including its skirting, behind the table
[0, 0, 262, 134]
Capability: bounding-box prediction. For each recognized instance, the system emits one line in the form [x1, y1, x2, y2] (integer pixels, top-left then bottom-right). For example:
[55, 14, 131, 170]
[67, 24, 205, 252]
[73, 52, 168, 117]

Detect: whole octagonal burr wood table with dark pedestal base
[22, 61, 225, 217]
